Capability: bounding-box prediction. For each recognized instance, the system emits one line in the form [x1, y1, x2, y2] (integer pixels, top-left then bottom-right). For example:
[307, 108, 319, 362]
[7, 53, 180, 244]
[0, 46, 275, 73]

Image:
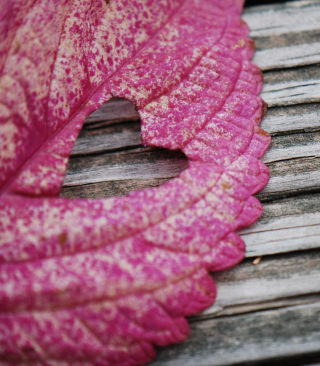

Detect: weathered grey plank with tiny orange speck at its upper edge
[202, 250, 320, 319]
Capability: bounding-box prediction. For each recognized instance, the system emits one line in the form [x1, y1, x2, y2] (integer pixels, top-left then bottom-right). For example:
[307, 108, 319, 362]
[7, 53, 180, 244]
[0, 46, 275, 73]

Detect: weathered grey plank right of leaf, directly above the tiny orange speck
[239, 193, 320, 257]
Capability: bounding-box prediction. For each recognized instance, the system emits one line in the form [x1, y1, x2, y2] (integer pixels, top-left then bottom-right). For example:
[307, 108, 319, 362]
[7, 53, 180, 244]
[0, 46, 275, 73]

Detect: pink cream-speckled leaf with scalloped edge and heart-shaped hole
[0, 0, 269, 366]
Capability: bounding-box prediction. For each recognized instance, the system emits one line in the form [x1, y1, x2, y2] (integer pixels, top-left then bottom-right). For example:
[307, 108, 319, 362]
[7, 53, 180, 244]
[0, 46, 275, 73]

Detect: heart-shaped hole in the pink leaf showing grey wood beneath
[61, 98, 188, 198]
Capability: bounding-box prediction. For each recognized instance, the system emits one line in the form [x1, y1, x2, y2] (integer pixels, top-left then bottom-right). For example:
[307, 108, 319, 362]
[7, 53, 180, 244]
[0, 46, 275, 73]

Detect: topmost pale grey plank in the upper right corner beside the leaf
[242, 0, 320, 38]
